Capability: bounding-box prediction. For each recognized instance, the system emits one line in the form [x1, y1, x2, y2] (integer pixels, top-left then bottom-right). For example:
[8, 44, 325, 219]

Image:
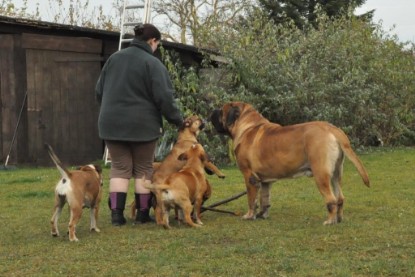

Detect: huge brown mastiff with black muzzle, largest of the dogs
[211, 102, 369, 224]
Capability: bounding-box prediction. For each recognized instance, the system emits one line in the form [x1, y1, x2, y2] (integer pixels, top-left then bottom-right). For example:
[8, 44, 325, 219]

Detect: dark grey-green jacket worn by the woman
[95, 39, 183, 141]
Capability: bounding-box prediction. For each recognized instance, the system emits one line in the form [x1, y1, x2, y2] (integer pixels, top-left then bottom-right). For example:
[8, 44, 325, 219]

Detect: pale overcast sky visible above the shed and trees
[13, 0, 415, 43]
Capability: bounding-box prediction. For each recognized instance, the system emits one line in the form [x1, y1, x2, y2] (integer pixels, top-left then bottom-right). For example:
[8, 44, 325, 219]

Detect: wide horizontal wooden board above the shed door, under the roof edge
[22, 33, 102, 54]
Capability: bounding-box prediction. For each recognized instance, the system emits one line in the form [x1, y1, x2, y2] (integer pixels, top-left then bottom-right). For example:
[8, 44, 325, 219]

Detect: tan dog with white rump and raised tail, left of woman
[45, 144, 102, 241]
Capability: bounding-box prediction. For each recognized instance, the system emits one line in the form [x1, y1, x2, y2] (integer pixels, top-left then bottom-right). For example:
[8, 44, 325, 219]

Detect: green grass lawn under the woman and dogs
[0, 148, 415, 276]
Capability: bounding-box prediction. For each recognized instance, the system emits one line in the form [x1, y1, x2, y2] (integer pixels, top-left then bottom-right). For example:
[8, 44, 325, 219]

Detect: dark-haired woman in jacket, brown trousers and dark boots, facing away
[95, 24, 183, 226]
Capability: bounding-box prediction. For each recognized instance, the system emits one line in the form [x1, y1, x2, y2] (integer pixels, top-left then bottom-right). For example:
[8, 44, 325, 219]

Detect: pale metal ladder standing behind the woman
[103, 0, 152, 165]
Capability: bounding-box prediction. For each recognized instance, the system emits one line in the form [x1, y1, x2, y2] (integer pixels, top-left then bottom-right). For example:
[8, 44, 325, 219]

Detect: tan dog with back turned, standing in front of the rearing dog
[146, 144, 219, 229]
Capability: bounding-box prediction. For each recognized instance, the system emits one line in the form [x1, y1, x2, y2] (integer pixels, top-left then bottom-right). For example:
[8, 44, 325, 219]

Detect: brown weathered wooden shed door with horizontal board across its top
[22, 34, 102, 165]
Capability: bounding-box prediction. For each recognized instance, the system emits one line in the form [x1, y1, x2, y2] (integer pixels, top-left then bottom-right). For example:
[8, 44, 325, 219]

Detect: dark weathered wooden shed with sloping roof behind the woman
[0, 16, 208, 165]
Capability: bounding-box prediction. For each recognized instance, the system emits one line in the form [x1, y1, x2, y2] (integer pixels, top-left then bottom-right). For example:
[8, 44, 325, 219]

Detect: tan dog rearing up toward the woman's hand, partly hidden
[131, 115, 225, 220]
